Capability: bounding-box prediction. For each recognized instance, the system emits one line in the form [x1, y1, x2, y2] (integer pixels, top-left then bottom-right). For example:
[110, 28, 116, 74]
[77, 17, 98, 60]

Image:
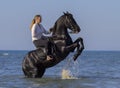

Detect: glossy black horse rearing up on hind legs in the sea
[22, 12, 84, 78]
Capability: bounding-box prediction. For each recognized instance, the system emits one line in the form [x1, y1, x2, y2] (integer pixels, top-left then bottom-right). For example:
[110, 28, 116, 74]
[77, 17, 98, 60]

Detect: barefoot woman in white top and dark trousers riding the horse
[30, 15, 52, 60]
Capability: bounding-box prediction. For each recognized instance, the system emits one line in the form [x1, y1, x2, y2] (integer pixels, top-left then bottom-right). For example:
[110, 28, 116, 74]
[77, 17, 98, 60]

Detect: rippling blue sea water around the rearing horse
[0, 50, 120, 88]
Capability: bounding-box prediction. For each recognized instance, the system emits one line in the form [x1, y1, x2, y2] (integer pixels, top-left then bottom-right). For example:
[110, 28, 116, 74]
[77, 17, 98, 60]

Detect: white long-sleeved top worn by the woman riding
[31, 24, 49, 41]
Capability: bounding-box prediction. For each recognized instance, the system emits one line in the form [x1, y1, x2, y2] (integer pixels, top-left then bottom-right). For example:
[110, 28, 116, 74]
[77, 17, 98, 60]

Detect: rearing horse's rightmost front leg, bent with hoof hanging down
[73, 38, 84, 61]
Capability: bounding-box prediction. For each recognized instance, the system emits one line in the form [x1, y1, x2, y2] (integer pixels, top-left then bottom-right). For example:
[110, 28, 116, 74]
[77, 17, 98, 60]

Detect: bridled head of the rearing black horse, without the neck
[63, 12, 81, 33]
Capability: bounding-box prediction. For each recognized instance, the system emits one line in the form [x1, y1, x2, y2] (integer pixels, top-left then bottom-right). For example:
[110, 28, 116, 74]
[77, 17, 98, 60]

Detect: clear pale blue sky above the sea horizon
[0, 0, 120, 50]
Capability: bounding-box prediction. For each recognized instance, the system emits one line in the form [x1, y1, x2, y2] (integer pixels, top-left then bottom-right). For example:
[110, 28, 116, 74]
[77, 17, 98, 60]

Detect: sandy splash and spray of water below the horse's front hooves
[61, 54, 79, 79]
